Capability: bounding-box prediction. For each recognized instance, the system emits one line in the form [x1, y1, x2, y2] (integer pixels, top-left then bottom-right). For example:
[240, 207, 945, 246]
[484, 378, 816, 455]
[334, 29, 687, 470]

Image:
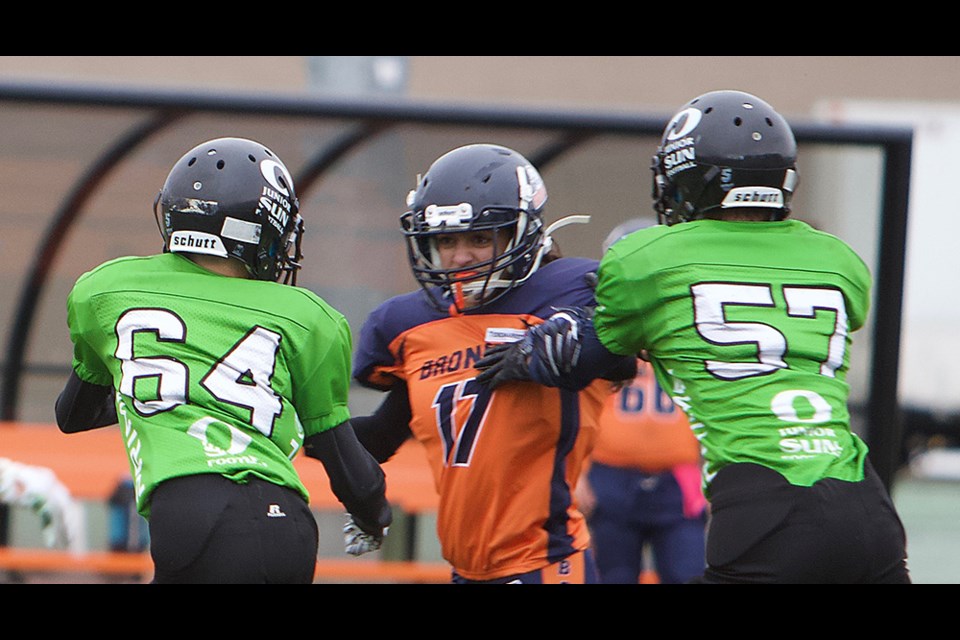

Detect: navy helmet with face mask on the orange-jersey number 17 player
[400, 144, 552, 312]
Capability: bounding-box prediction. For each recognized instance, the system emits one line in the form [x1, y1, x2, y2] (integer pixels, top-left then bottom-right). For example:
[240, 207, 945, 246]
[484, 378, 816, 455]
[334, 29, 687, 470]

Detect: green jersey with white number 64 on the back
[67, 253, 352, 516]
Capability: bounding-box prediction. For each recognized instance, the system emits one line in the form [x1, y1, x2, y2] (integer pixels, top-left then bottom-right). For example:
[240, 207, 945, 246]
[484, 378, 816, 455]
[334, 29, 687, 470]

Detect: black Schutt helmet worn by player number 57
[652, 91, 799, 225]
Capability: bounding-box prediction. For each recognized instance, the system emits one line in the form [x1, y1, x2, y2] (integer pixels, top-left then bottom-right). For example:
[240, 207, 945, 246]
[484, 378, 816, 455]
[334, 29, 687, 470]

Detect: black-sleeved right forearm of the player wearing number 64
[303, 420, 393, 539]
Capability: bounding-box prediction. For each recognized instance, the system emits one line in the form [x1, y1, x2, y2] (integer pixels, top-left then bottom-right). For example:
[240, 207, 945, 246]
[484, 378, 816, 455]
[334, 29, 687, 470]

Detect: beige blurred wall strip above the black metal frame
[0, 55, 960, 117]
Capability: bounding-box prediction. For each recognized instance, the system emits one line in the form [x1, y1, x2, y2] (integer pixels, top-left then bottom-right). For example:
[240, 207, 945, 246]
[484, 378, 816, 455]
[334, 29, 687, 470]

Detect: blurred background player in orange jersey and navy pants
[577, 216, 707, 584]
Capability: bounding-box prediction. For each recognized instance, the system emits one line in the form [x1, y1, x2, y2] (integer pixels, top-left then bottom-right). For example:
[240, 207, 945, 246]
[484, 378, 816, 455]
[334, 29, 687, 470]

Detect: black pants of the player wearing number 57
[694, 460, 910, 584]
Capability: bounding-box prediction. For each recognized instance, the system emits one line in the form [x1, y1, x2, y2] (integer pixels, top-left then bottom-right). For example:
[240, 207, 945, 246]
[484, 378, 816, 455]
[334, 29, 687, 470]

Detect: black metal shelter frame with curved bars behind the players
[0, 82, 913, 488]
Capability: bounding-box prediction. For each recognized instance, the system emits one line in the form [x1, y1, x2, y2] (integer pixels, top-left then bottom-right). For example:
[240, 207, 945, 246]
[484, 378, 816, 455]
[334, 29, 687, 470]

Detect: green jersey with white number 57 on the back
[594, 220, 870, 492]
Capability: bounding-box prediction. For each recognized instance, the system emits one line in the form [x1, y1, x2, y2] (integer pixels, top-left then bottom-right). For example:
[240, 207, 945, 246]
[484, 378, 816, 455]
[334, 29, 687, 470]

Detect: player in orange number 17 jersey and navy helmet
[354, 144, 635, 584]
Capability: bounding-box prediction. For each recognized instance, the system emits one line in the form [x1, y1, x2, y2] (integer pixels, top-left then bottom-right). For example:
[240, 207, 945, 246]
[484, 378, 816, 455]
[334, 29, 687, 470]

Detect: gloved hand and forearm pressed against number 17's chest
[474, 309, 637, 391]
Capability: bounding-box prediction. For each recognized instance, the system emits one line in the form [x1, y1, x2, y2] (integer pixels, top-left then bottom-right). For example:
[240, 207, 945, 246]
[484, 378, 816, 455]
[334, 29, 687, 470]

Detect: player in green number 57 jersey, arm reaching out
[477, 91, 910, 584]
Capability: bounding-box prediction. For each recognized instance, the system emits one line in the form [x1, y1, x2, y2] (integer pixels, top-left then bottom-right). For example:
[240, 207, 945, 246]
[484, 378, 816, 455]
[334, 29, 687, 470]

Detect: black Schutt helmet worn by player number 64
[154, 138, 303, 285]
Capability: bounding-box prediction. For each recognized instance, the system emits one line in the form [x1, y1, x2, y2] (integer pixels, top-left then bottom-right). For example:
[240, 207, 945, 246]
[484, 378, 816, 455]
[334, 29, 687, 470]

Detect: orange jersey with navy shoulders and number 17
[354, 258, 610, 580]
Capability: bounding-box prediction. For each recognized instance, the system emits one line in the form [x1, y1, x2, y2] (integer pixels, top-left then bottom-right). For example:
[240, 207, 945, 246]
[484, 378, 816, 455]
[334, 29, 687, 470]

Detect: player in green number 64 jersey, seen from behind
[56, 138, 391, 583]
